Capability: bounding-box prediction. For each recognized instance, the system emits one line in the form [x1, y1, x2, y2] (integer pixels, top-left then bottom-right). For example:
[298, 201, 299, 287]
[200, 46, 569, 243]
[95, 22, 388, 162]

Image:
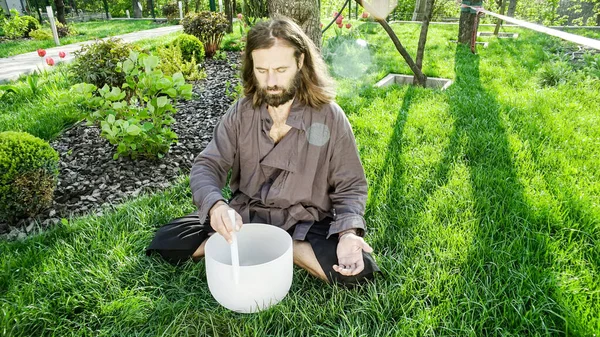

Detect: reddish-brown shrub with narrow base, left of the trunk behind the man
[182, 11, 228, 57]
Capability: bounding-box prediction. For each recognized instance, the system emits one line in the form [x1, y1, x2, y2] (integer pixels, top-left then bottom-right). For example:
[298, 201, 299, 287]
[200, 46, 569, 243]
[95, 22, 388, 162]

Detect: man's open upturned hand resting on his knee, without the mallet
[333, 234, 373, 276]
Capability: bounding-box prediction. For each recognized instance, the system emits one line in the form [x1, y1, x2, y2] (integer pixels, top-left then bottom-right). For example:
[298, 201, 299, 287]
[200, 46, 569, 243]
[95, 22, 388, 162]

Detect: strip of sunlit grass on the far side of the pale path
[0, 20, 173, 57]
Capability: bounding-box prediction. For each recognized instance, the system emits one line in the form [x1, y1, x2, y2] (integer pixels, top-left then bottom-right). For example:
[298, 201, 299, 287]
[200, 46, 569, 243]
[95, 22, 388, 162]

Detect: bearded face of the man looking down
[252, 43, 304, 107]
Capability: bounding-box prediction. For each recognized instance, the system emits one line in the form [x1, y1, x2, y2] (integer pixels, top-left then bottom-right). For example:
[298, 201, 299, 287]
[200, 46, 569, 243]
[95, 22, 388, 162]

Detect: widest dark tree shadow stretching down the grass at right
[440, 46, 567, 335]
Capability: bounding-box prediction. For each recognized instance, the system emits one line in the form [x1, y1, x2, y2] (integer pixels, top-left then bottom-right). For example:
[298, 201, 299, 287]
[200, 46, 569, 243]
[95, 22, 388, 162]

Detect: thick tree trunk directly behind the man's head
[268, 0, 321, 50]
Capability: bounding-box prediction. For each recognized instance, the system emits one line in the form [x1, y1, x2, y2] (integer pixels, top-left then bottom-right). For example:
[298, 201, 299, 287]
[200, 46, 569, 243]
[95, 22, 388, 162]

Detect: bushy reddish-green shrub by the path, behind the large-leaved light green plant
[71, 38, 139, 88]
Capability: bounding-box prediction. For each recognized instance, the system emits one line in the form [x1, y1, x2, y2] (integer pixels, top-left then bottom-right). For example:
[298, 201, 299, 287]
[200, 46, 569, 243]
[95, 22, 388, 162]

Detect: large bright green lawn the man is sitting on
[0, 25, 600, 336]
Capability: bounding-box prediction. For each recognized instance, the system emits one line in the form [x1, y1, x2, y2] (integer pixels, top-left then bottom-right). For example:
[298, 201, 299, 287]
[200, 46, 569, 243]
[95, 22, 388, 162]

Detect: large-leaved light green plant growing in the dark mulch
[72, 52, 192, 159]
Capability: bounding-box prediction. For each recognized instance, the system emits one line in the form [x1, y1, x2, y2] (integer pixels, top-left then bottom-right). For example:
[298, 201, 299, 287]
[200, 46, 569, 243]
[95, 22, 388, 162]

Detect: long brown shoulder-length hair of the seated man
[242, 16, 335, 109]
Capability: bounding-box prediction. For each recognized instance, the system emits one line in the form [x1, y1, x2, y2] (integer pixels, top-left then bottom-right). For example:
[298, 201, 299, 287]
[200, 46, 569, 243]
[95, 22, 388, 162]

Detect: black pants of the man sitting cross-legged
[146, 213, 379, 285]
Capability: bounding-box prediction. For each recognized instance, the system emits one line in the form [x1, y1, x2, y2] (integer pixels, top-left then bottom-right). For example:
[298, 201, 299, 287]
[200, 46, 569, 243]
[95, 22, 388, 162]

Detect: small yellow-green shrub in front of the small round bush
[156, 45, 206, 81]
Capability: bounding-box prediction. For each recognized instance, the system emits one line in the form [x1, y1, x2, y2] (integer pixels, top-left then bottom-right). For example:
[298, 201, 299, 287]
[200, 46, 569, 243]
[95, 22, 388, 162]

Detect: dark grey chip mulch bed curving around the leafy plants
[0, 52, 240, 240]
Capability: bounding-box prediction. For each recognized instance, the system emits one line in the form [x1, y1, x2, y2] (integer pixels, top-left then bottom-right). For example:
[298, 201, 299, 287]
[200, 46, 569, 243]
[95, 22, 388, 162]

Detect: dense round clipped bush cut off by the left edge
[0, 131, 58, 222]
